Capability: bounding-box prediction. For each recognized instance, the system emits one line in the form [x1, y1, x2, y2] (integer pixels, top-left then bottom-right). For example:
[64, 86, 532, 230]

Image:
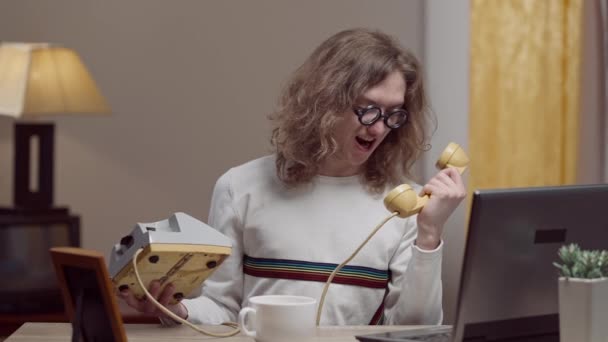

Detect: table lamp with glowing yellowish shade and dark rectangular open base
[0, 42, 110, 213]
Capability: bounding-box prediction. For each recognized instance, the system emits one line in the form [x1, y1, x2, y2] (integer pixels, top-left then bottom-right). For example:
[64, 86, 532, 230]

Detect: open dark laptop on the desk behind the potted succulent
[356, 184, 608, 342]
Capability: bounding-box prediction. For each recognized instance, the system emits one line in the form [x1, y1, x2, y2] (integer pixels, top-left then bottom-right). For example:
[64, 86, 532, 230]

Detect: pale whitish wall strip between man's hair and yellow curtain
[424, 0, 469, 323]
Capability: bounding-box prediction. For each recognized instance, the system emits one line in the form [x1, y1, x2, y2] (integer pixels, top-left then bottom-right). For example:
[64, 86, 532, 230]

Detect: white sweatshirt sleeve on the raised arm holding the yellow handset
[384, 216, 443, 325]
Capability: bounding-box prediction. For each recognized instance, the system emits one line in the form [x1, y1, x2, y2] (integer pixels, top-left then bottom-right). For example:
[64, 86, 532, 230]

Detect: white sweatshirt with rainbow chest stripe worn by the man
[183, 156, 443, 325]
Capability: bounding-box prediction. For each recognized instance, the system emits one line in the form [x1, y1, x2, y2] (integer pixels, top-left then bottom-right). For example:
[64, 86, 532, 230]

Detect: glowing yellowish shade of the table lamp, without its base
[0, 43, 110, 118]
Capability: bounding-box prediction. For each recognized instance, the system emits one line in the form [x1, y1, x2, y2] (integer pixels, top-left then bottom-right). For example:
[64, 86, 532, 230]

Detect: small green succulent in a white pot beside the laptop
[553, 244, 608, 342]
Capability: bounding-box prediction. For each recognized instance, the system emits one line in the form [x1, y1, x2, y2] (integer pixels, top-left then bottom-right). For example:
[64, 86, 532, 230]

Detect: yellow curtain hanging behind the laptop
[469, 0, 583, 189]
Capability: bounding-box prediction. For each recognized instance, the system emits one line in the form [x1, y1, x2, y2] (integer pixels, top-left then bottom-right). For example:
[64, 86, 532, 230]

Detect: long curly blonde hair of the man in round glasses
[270, 28, 434, 192]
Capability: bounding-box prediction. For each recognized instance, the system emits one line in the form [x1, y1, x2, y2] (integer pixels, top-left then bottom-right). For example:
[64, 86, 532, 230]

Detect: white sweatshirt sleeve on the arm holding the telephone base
[182, 171, 243, 324]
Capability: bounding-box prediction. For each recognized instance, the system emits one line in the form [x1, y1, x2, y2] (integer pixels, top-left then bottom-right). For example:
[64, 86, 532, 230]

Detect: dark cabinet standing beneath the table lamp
[0, 208, 80, 335]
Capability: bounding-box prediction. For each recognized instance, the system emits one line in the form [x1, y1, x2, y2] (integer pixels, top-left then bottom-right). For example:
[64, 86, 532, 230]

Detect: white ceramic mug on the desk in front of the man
[239, 295, 317, 342]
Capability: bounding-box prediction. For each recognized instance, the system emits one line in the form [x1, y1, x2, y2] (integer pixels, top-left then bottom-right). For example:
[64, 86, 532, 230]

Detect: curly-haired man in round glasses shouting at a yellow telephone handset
[122, 29, 466, 325]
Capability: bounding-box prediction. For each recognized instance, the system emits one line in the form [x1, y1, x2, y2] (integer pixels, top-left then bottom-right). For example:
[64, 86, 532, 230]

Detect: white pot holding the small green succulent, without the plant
[559, 278, 608, 342]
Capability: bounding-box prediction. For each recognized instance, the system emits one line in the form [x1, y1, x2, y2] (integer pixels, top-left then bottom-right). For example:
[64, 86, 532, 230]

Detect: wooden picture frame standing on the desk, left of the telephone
[50, 247, 127, 342]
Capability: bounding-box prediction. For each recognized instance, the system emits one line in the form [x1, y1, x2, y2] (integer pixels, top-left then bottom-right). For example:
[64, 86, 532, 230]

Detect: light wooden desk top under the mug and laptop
[5, 323, 420, 342]
